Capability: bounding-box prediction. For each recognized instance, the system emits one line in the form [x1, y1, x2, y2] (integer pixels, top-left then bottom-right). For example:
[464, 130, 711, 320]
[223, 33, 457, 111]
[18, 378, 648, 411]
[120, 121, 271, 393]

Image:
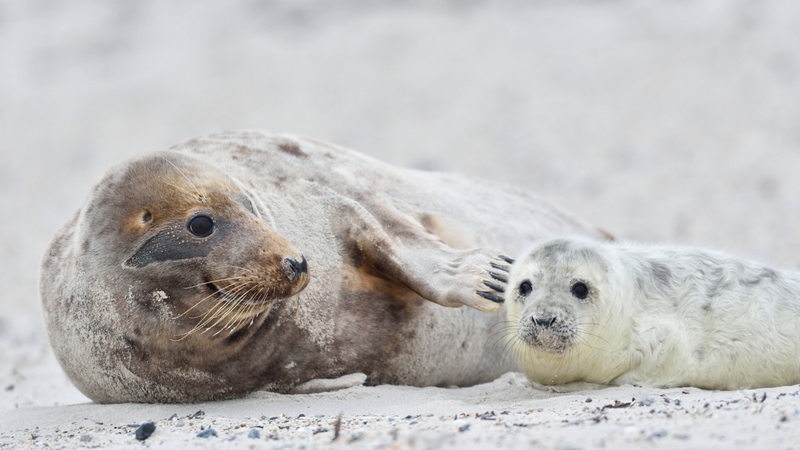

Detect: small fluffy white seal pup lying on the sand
[496, 239, 800, 389]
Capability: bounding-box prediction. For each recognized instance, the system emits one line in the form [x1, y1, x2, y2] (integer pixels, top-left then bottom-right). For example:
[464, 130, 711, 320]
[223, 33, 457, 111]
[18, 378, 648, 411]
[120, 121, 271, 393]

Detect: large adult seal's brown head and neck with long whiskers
[41, 152, 309, 401]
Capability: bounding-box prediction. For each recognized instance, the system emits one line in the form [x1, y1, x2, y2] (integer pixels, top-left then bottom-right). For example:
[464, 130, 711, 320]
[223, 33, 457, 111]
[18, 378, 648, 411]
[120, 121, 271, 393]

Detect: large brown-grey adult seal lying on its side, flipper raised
[40, 131, 601, 402]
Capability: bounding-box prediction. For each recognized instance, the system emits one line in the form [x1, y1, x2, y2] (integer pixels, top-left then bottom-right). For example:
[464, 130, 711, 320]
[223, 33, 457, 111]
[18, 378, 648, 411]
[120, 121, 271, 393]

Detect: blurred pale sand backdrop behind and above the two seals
[0, 0, 800, 407]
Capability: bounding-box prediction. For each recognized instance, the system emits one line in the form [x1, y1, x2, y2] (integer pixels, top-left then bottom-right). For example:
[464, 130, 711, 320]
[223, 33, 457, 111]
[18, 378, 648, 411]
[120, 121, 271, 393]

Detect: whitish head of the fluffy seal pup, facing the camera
[505, 239, 623, 384]
